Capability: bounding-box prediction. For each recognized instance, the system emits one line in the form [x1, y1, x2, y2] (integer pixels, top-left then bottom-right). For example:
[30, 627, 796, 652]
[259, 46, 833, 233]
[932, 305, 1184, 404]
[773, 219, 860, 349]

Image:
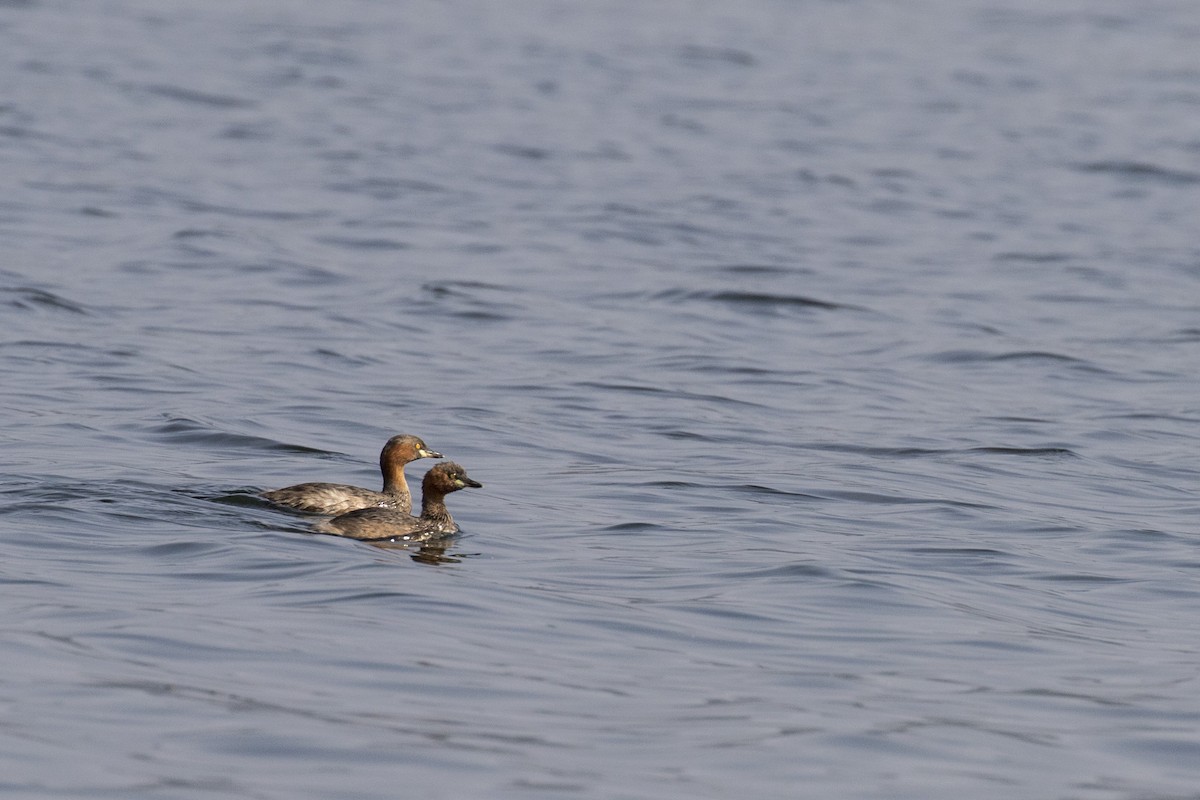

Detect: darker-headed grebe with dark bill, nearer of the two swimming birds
[316, 462, 484, 542]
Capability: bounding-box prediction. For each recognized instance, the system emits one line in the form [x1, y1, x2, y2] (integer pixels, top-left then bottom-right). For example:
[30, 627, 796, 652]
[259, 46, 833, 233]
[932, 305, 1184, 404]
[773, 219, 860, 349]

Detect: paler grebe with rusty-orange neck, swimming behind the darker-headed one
[263, 434, 442, 513]
